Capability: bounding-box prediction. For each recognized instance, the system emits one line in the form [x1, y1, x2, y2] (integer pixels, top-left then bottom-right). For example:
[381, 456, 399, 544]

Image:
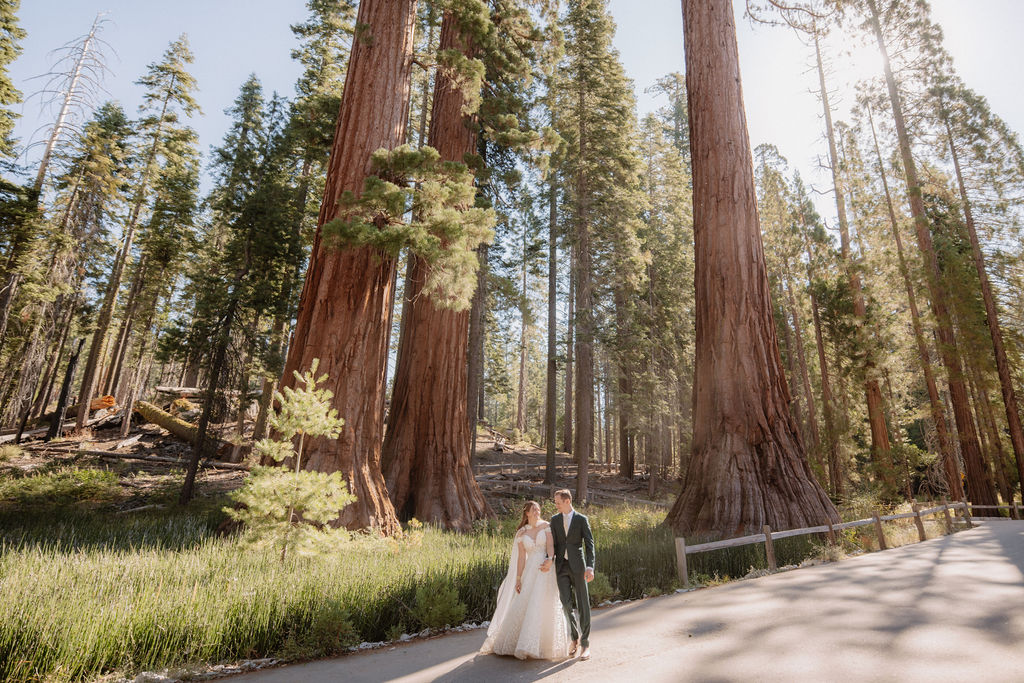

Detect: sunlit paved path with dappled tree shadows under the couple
[234, 521, 1024, 683]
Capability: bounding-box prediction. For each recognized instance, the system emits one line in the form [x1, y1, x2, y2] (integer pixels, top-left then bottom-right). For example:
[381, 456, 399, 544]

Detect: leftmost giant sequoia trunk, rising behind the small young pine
[282, 0, 416, 533]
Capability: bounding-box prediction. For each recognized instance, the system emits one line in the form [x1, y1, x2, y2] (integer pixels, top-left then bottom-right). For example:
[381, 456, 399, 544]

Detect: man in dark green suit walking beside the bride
[545, 488, 594, 659]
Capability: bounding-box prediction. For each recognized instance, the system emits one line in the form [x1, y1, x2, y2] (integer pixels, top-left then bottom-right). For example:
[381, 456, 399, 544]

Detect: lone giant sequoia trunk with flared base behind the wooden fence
[668, 0, 839, 537]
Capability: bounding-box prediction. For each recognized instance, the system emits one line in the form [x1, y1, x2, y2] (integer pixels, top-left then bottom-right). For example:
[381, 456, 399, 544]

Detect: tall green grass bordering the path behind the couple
[0, 503, 675, 681]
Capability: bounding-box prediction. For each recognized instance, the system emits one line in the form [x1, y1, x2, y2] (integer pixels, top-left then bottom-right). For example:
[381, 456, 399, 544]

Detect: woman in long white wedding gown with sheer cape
[480, 501, 569, 659]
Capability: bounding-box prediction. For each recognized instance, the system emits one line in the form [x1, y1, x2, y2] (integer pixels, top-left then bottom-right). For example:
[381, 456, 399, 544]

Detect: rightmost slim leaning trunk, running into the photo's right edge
[944, 114, 1024, 492]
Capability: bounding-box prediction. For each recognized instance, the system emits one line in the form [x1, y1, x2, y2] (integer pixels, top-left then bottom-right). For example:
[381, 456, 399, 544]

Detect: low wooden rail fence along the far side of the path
[676, 501, 983, 588]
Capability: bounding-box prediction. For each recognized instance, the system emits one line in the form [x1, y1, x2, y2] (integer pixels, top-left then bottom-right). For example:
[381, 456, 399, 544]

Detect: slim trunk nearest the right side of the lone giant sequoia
[814, 32, 892, 481]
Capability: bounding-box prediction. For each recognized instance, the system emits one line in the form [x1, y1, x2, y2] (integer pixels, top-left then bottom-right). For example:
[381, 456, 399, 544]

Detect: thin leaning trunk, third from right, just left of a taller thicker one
[867, 106, 964, 500]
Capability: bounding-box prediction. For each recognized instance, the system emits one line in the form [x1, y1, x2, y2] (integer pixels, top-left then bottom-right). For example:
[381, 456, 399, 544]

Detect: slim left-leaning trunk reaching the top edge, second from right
[867, 0, 995, 505]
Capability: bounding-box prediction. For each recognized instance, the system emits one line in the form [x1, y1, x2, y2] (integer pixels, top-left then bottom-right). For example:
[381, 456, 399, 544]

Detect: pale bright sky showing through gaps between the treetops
[10, 0, 1024, 229]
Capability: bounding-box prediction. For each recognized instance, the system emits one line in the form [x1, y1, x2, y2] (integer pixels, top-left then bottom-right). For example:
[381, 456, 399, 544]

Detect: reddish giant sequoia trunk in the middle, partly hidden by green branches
[381, 12, 494, 531]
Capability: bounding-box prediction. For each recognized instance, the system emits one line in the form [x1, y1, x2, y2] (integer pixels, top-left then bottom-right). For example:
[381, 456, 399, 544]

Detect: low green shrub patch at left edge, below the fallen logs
[0, 467, 122, 507]
